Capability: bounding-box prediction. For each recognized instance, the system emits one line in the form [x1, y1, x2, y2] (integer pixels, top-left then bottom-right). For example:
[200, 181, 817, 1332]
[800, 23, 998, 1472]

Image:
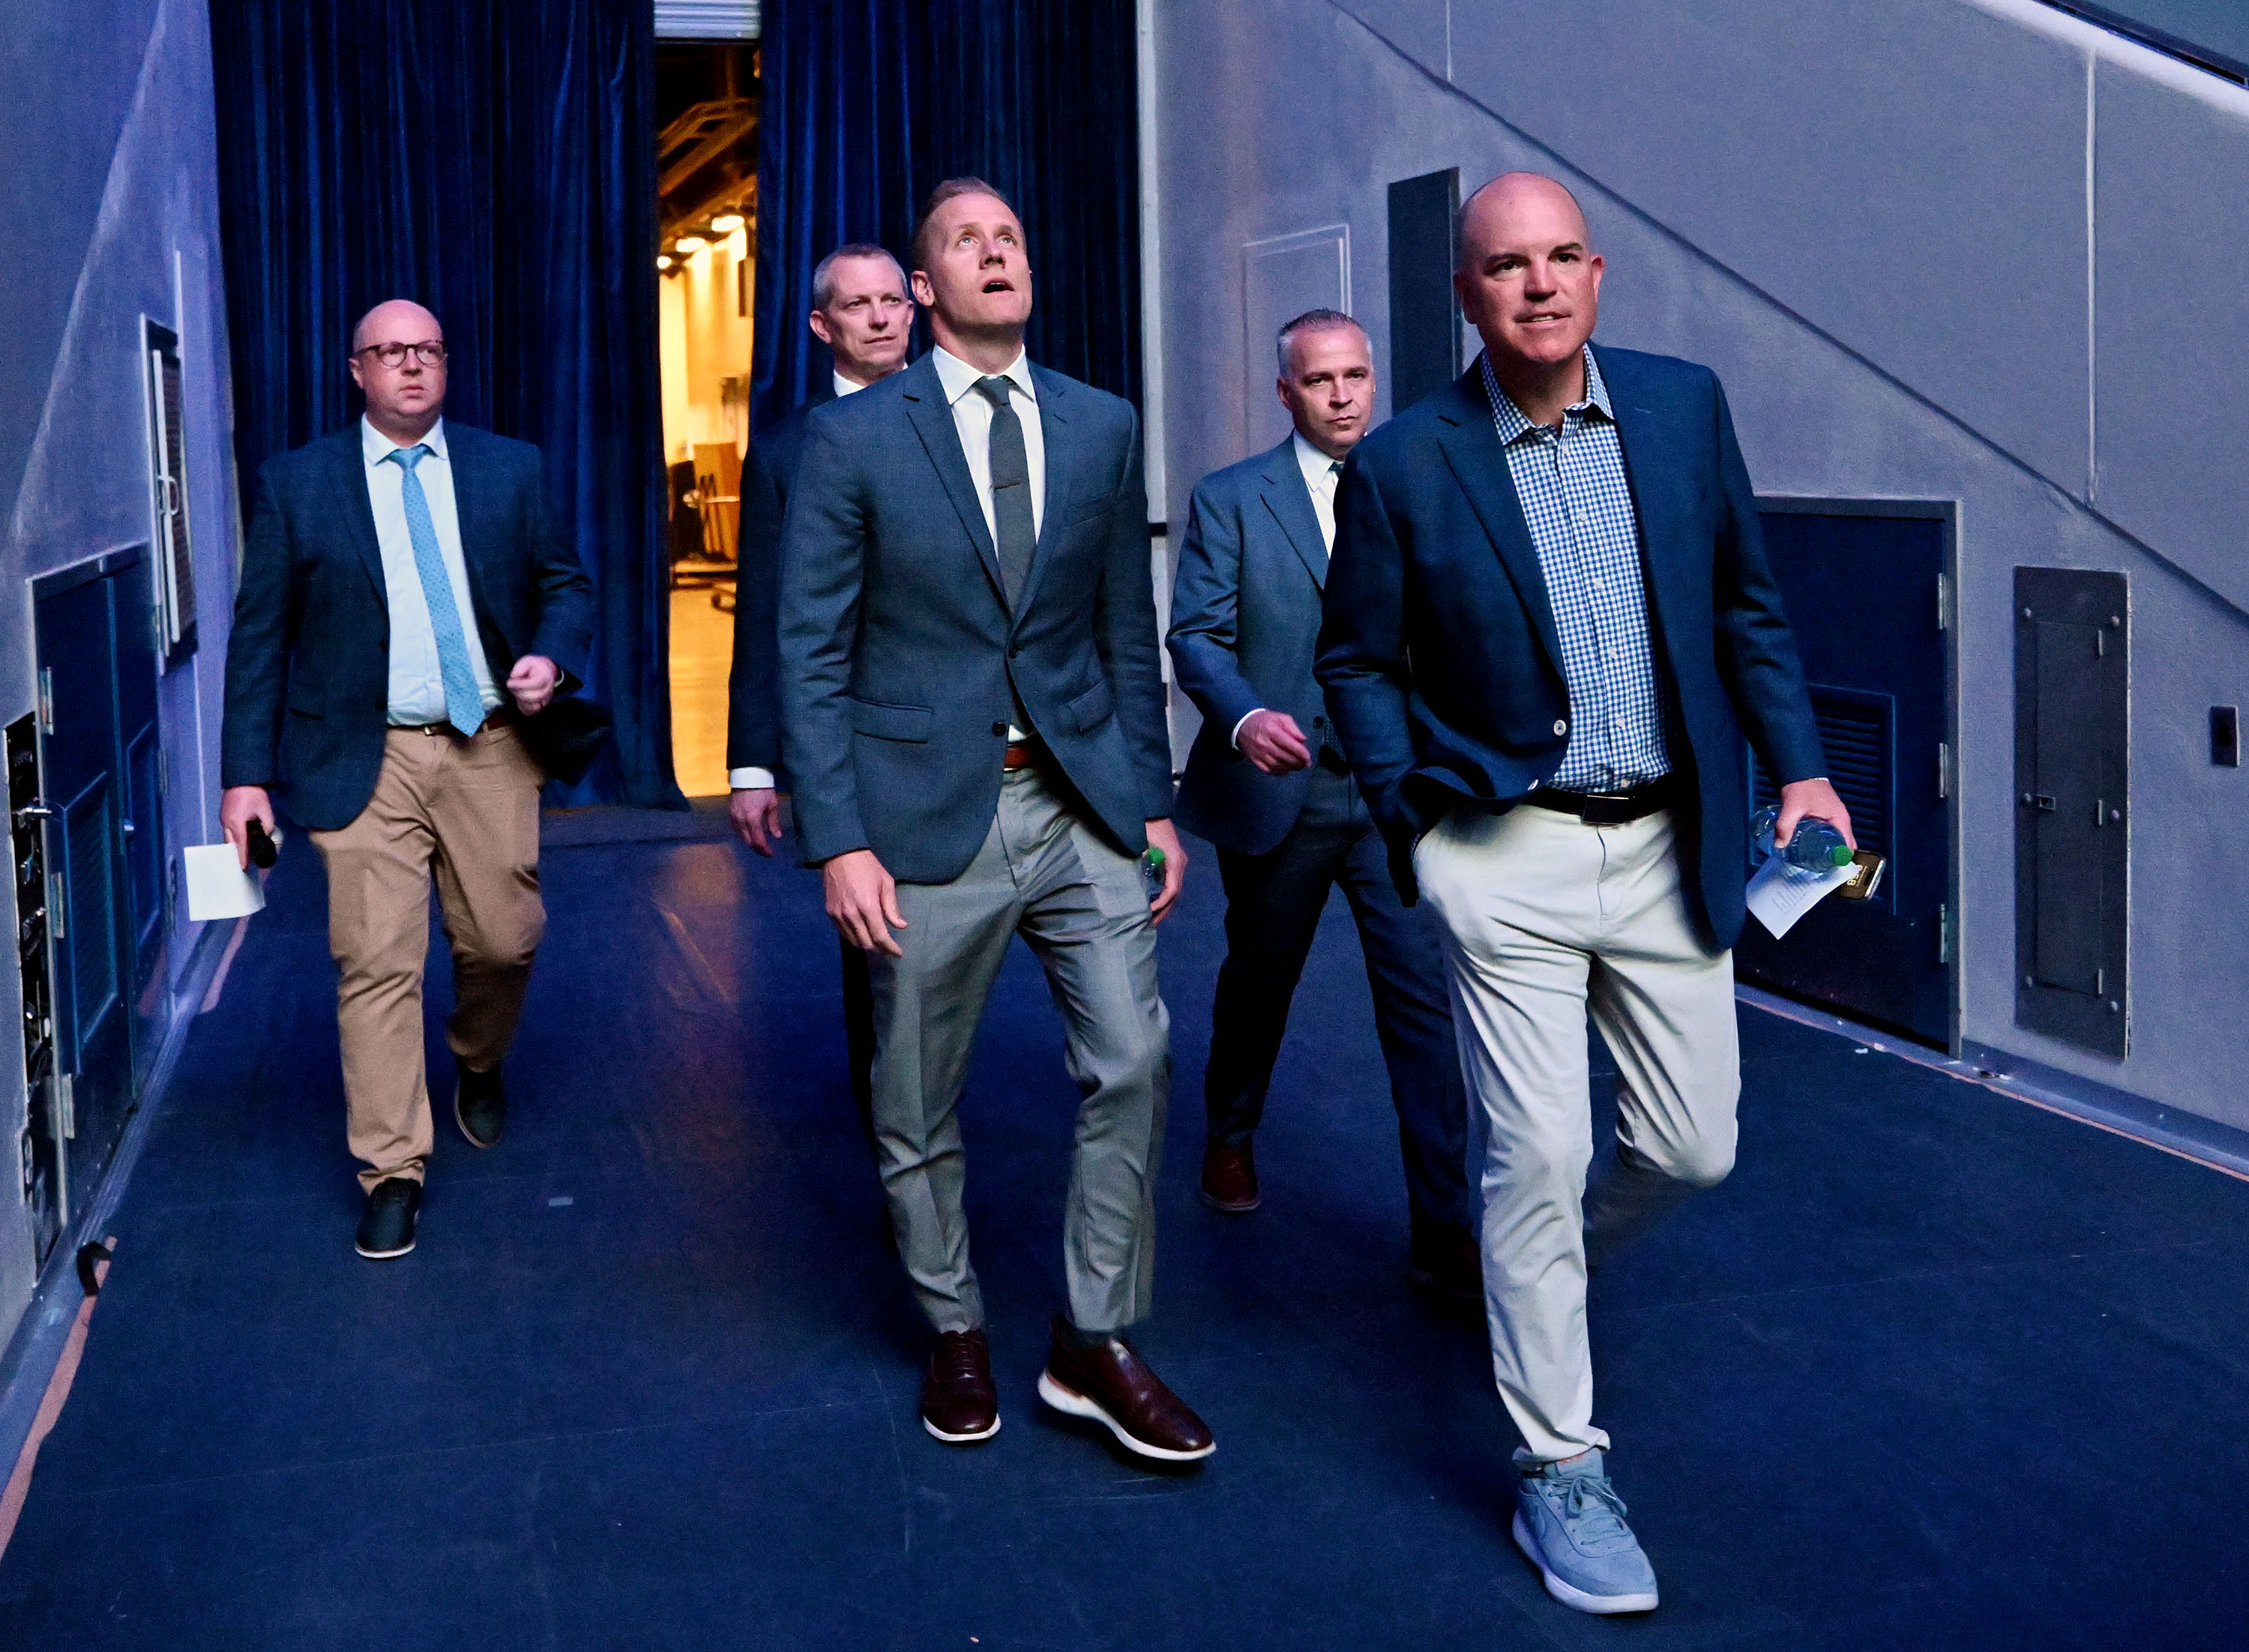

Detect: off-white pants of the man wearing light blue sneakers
[1412, 805, 1741, 1461]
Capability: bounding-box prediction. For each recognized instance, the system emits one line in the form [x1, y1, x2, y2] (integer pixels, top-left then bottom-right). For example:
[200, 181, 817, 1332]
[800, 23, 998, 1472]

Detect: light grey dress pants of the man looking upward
[868, 769, 1172, 1330]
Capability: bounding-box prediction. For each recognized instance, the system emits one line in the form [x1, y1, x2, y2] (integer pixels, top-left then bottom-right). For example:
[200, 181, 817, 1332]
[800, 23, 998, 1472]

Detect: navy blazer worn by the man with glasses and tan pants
[220, 420, 594, 831]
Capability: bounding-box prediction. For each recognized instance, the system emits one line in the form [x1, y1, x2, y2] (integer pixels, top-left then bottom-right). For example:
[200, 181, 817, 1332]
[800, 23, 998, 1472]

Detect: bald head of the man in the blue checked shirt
[1453, 173, 1601, 411]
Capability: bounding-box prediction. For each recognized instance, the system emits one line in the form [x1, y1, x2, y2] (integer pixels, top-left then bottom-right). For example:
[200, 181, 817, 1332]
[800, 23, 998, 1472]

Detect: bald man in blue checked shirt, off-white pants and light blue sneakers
[1318, 173, 1849, 1612]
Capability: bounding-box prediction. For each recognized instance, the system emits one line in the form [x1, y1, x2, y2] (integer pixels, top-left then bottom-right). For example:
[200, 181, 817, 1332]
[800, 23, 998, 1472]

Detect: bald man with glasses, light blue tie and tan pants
[220, 299, 594, 1256]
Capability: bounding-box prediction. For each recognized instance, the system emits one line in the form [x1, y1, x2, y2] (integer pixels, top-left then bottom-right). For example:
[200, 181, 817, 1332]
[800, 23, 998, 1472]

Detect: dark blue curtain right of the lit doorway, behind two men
[753, 0, 1140, 425]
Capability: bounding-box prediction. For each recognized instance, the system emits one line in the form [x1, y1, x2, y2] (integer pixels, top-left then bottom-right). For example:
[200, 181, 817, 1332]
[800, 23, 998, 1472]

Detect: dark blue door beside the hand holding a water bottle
[1734, 499, 1952, 1047]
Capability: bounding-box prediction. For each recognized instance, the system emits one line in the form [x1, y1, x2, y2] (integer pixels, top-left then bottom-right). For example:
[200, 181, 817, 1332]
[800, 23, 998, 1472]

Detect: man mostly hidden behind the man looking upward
[726, 241, 913, 1139]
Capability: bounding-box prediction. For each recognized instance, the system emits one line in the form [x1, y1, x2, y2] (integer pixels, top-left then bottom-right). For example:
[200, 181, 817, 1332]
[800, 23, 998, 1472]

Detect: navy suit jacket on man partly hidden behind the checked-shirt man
[1169, 436, 1327, 854]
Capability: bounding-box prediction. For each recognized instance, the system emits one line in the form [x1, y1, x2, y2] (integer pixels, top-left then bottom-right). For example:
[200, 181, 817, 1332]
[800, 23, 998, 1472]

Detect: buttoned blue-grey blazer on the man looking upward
[780, 355, 1172, 883]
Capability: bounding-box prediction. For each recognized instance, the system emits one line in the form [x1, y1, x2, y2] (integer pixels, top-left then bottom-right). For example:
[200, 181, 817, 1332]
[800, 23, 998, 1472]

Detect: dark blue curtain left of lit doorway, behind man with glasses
[211, 0, 686, 807]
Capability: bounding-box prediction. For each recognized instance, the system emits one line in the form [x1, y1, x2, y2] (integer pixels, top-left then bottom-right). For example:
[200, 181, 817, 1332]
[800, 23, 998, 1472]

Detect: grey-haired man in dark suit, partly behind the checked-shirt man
[1172, 310, 1482, 1301]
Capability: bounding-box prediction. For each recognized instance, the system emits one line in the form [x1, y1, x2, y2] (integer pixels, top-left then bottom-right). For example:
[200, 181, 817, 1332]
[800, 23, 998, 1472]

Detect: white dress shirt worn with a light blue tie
[360, 418, 499, 729]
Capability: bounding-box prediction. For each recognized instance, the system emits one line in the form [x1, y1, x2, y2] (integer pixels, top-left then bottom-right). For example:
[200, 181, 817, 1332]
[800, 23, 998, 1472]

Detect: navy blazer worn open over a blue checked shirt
[1316, 346, 1826, 946]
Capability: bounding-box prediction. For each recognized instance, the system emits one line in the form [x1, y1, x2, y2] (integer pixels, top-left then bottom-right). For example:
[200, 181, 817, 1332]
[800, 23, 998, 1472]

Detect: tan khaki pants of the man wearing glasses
[313, 724, 547, 1187]
